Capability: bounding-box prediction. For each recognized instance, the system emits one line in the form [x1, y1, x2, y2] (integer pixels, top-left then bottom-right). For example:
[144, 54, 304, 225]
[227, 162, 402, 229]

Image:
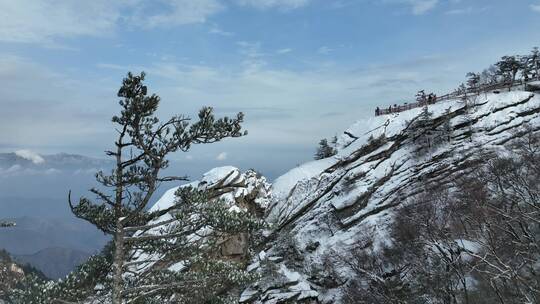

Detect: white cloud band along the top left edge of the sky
[0, 0, 223, 46]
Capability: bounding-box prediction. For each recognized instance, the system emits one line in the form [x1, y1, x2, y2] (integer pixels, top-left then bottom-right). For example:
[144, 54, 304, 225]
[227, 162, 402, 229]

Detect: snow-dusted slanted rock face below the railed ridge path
[240, 91, 540, 303]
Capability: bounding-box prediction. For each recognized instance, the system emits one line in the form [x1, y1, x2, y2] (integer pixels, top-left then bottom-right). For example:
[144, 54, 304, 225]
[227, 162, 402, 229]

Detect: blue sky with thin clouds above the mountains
[0, 0, 540, 177]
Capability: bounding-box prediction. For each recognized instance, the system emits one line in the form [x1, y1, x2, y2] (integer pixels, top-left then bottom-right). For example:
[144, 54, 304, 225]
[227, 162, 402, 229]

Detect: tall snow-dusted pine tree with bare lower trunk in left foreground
[69, 73, 256, 304]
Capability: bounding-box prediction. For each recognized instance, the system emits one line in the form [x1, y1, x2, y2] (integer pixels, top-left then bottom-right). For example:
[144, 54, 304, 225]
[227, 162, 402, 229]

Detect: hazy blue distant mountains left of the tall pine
[0, 150, 111, 278]
